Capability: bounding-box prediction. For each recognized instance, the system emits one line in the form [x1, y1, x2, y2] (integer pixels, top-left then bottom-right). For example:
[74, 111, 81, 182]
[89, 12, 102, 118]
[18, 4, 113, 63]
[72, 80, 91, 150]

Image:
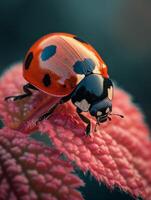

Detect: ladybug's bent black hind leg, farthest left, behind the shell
[5, 83, 38, 101]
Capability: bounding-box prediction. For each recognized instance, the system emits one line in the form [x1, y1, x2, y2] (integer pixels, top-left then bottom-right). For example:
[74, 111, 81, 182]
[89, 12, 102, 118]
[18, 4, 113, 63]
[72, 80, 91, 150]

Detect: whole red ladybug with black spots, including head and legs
[5, 33, 123, 135]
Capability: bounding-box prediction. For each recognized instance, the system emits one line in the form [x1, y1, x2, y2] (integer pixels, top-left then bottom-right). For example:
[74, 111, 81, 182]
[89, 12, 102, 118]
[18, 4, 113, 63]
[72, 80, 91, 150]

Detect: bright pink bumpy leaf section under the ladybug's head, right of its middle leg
[40, 89, 151, 200]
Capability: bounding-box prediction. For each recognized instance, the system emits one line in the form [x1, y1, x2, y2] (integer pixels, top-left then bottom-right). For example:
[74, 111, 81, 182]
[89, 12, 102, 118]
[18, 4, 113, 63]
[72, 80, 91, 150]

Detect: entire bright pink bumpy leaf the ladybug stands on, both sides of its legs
[0, 63, 151, 200]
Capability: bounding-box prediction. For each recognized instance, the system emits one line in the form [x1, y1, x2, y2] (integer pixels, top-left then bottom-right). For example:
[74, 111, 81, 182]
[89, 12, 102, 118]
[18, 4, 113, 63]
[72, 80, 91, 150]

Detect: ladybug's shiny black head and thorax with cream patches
[71, 74, 113, 114]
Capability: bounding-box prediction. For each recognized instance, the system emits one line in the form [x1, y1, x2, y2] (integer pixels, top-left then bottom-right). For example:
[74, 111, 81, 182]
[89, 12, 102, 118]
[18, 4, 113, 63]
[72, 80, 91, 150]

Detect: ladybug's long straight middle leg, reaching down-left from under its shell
[36, 93, 72, 124]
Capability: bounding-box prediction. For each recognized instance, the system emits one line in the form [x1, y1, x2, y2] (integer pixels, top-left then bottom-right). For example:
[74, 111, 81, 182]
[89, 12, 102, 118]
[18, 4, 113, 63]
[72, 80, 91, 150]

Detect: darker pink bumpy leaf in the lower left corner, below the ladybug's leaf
[0, 128, 83, 200]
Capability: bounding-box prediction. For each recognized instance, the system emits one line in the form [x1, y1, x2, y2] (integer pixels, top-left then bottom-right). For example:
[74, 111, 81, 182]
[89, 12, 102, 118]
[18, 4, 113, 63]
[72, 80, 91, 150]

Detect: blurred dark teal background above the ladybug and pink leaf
[0, 0, 151, 200]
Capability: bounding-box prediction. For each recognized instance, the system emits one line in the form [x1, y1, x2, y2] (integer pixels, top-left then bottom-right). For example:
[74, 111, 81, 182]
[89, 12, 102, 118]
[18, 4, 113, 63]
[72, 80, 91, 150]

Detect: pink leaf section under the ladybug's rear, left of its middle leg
[0, 64, 59, 132]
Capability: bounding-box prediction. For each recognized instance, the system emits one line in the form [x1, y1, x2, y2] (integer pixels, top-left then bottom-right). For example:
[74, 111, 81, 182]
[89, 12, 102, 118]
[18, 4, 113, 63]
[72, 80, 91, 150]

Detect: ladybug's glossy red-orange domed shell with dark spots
[23, 33, 108, 97]
